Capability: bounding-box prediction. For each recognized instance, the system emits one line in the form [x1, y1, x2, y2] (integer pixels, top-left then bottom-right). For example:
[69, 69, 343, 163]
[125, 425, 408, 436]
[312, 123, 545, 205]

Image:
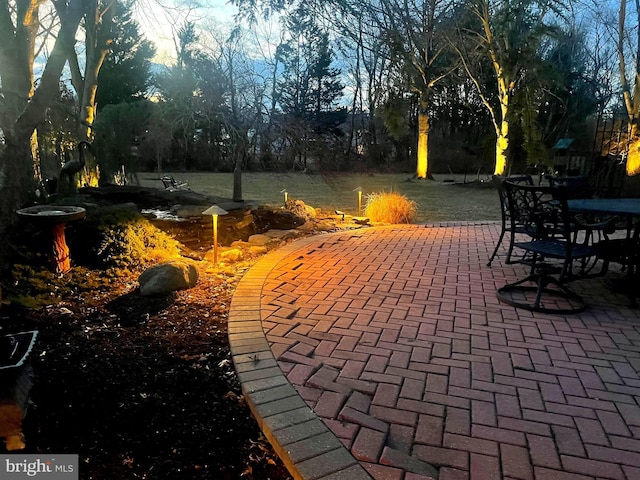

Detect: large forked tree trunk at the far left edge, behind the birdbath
[0, 0, 86, 233]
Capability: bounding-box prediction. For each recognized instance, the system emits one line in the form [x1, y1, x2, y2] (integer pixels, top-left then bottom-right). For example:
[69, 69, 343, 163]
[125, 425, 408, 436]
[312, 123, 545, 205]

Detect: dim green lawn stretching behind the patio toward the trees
[138, 172, 500, 223]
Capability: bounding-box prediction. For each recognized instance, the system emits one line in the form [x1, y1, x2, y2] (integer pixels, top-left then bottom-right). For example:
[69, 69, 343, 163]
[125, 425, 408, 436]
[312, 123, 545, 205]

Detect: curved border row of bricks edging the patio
[228, 221, 496, 480]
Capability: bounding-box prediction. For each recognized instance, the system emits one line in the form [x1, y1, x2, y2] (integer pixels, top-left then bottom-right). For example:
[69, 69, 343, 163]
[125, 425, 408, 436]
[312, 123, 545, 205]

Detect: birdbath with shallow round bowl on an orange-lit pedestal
[16, 205, 87, 273]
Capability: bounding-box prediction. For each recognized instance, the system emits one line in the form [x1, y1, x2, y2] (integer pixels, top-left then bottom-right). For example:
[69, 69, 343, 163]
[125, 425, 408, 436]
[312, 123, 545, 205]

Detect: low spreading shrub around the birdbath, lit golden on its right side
[0, 210, 180, 308]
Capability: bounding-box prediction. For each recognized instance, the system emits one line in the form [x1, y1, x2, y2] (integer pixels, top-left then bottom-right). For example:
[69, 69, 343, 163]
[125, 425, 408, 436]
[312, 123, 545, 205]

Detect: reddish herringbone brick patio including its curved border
[229, 223, 640, 480]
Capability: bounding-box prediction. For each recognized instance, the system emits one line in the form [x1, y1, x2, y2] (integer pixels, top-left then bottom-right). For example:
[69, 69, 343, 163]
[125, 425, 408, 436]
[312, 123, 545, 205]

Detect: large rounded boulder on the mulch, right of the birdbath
[138, 260, 198, 296]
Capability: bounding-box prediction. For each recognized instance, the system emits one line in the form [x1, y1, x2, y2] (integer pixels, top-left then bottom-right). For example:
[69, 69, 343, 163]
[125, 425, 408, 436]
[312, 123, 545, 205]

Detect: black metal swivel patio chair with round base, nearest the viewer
[497, 181, 608, 313]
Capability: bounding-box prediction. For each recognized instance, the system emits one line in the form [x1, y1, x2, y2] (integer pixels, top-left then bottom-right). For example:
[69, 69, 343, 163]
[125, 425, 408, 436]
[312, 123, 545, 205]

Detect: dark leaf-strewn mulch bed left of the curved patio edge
[0, 238, 291, 480]
